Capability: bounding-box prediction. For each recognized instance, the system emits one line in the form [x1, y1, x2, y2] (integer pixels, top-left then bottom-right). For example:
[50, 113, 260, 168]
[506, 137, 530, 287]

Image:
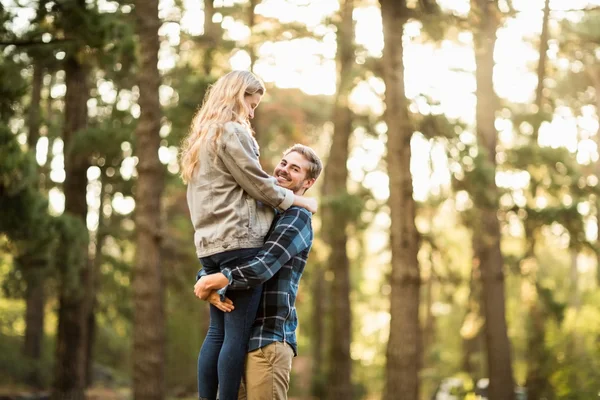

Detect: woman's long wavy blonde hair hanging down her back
[180, 71, 266, 183]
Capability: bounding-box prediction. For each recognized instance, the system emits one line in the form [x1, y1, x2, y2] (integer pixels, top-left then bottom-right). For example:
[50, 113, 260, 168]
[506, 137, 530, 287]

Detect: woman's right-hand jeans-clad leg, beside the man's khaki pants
[218, 286, 262, 400]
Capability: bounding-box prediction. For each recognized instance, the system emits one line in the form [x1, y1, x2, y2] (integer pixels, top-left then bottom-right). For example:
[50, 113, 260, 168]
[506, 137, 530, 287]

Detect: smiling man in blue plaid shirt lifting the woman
[194, 144, 323, 400]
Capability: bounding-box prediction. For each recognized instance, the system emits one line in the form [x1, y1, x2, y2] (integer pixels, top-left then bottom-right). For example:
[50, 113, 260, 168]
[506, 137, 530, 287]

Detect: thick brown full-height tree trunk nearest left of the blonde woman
[132, 0, 166, 400]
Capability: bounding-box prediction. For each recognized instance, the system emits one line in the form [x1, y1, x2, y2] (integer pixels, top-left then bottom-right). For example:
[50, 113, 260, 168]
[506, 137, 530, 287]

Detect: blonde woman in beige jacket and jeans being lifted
[181, 71, 317, 400]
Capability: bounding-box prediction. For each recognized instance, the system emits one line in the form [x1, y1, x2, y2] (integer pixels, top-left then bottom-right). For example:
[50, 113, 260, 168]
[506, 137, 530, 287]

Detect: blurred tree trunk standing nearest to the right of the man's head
[323, 0, 354, 400]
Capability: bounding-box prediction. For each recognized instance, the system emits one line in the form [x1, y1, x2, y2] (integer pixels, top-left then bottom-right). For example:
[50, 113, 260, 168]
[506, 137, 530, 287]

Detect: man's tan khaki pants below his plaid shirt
[238, 342, 294, 400]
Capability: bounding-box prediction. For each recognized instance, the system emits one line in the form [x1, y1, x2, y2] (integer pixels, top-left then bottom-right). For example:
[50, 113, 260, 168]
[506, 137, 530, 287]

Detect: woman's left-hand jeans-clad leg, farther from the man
[198, 304, 225, 400]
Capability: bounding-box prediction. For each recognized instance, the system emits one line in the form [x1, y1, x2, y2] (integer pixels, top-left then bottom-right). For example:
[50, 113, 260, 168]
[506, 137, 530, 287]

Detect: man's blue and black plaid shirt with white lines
[222, 207, 313, 355]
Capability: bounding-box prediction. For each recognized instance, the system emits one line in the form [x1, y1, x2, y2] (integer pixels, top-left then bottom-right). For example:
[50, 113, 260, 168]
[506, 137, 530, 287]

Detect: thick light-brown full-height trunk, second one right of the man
[380, 0, 421, 400]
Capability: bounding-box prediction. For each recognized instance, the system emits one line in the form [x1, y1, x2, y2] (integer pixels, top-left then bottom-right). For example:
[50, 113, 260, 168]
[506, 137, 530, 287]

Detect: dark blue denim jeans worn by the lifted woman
[198, 249, 262, 400]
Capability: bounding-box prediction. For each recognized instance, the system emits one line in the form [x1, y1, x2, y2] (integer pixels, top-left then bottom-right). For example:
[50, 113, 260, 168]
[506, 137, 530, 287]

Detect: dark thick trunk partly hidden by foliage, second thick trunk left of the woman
[54, 14, 90, 400]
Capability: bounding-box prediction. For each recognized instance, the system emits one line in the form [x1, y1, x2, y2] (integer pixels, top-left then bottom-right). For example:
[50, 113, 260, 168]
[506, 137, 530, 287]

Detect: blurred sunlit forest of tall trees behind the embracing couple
[0, 0, 600, 400]
